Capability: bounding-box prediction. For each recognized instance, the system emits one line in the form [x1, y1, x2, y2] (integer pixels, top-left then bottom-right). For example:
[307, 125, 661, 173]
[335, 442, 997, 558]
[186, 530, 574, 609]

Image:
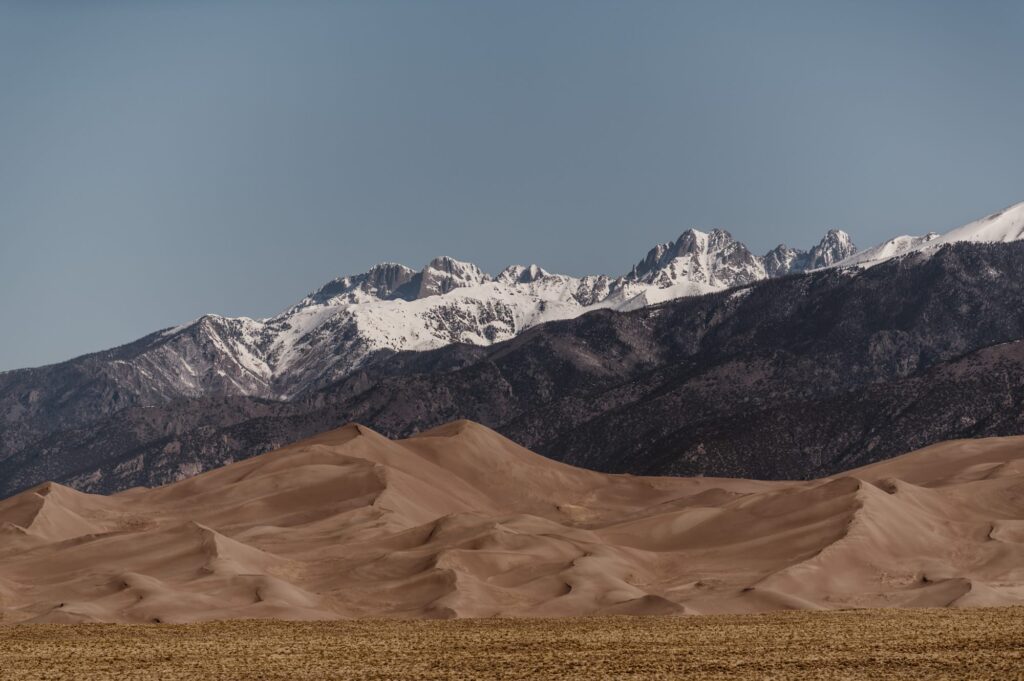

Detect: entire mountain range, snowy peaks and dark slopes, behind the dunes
[0, 197, 1024, 493]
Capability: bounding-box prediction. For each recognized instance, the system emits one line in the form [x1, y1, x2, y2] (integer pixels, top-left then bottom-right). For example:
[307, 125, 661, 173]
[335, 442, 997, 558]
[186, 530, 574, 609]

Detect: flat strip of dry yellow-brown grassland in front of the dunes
[0, 607, 1024, 681]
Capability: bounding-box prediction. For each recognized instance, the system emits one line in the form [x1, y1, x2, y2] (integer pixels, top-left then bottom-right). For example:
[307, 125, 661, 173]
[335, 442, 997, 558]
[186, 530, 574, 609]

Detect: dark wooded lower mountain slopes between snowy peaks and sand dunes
[0, 242, 1024, 494]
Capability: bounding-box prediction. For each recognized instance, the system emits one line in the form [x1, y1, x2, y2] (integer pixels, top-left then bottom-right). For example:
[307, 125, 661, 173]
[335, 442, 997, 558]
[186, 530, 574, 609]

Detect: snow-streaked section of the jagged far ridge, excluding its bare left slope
[131, 229, 853, 399]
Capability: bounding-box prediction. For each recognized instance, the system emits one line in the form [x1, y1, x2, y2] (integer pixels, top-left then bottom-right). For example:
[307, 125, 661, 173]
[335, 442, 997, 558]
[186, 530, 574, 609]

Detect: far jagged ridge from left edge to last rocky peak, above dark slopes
[0, 229, 855, 461]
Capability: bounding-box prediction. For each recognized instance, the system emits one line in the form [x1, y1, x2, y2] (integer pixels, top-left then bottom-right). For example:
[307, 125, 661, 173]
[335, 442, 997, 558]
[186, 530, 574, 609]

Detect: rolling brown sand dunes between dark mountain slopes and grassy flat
[0, 421, 1024, 623]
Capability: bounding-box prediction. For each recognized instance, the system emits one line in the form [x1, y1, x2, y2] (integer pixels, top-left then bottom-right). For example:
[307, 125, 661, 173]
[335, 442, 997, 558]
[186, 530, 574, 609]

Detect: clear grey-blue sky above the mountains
[0, 0, 1024, 370]
